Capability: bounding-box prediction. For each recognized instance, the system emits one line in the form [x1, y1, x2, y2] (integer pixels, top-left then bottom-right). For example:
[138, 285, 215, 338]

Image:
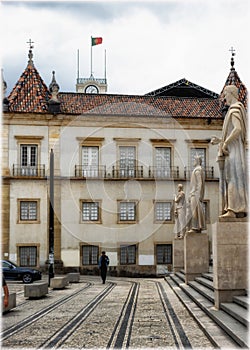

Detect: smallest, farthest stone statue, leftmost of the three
[174, 184, 186, 238]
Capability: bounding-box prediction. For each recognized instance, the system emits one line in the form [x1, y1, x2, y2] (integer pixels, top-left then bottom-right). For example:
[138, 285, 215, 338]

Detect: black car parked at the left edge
[2, 260, 42, 283]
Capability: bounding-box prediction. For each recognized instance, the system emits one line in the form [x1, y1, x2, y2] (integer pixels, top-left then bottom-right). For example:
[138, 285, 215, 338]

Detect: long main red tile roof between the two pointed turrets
[59, 93, 221, 118]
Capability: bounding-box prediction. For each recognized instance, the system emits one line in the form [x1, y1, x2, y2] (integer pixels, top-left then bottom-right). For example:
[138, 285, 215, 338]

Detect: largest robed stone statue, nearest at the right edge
[211, 85, 248, 217]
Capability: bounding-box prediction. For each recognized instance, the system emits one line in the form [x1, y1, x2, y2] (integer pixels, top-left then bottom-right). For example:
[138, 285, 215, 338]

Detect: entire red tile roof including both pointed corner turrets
[5, 52, 247, 118]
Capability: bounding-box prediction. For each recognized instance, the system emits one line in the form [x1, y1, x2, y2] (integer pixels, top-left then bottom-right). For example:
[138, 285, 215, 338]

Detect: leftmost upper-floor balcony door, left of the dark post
[20, 145, 38, 176]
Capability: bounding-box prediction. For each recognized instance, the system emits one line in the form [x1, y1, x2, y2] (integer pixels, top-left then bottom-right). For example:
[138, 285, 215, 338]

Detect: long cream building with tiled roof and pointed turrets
[2, 50, 246, 276]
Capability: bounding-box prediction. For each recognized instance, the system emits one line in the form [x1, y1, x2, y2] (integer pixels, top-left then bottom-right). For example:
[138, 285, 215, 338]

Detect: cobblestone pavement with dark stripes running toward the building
[1, 276, 214, 349]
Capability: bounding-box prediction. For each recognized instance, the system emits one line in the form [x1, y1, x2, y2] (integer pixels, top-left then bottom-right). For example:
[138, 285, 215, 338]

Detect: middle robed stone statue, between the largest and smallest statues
[188, 155, 206, 233]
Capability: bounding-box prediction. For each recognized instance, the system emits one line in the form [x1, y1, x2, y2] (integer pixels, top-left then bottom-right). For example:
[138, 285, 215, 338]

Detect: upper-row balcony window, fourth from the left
[155, 147, 171, 177]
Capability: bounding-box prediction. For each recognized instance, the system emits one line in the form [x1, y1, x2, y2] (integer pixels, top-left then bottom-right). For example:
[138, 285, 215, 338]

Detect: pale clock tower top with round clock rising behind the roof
[76, 74, 108, 94]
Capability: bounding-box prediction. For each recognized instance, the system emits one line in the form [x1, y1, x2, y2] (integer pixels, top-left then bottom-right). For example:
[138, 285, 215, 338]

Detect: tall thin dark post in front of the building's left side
[48, 149, 54, 286]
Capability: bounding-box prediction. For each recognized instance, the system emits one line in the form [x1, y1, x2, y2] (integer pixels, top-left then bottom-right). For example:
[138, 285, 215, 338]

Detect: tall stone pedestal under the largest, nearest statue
[213, 218, 248, 308]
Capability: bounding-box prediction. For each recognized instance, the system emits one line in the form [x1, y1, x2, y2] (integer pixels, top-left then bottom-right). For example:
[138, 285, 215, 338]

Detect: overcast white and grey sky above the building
[1, 0, 250, 95]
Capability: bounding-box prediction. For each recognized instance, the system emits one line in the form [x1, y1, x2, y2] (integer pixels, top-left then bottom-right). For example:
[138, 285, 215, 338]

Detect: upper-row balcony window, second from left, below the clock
[82, 146, 99, 177]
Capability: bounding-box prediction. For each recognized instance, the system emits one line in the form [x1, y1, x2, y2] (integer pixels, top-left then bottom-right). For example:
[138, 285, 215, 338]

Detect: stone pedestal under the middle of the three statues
[184, 233, 209, 283]
